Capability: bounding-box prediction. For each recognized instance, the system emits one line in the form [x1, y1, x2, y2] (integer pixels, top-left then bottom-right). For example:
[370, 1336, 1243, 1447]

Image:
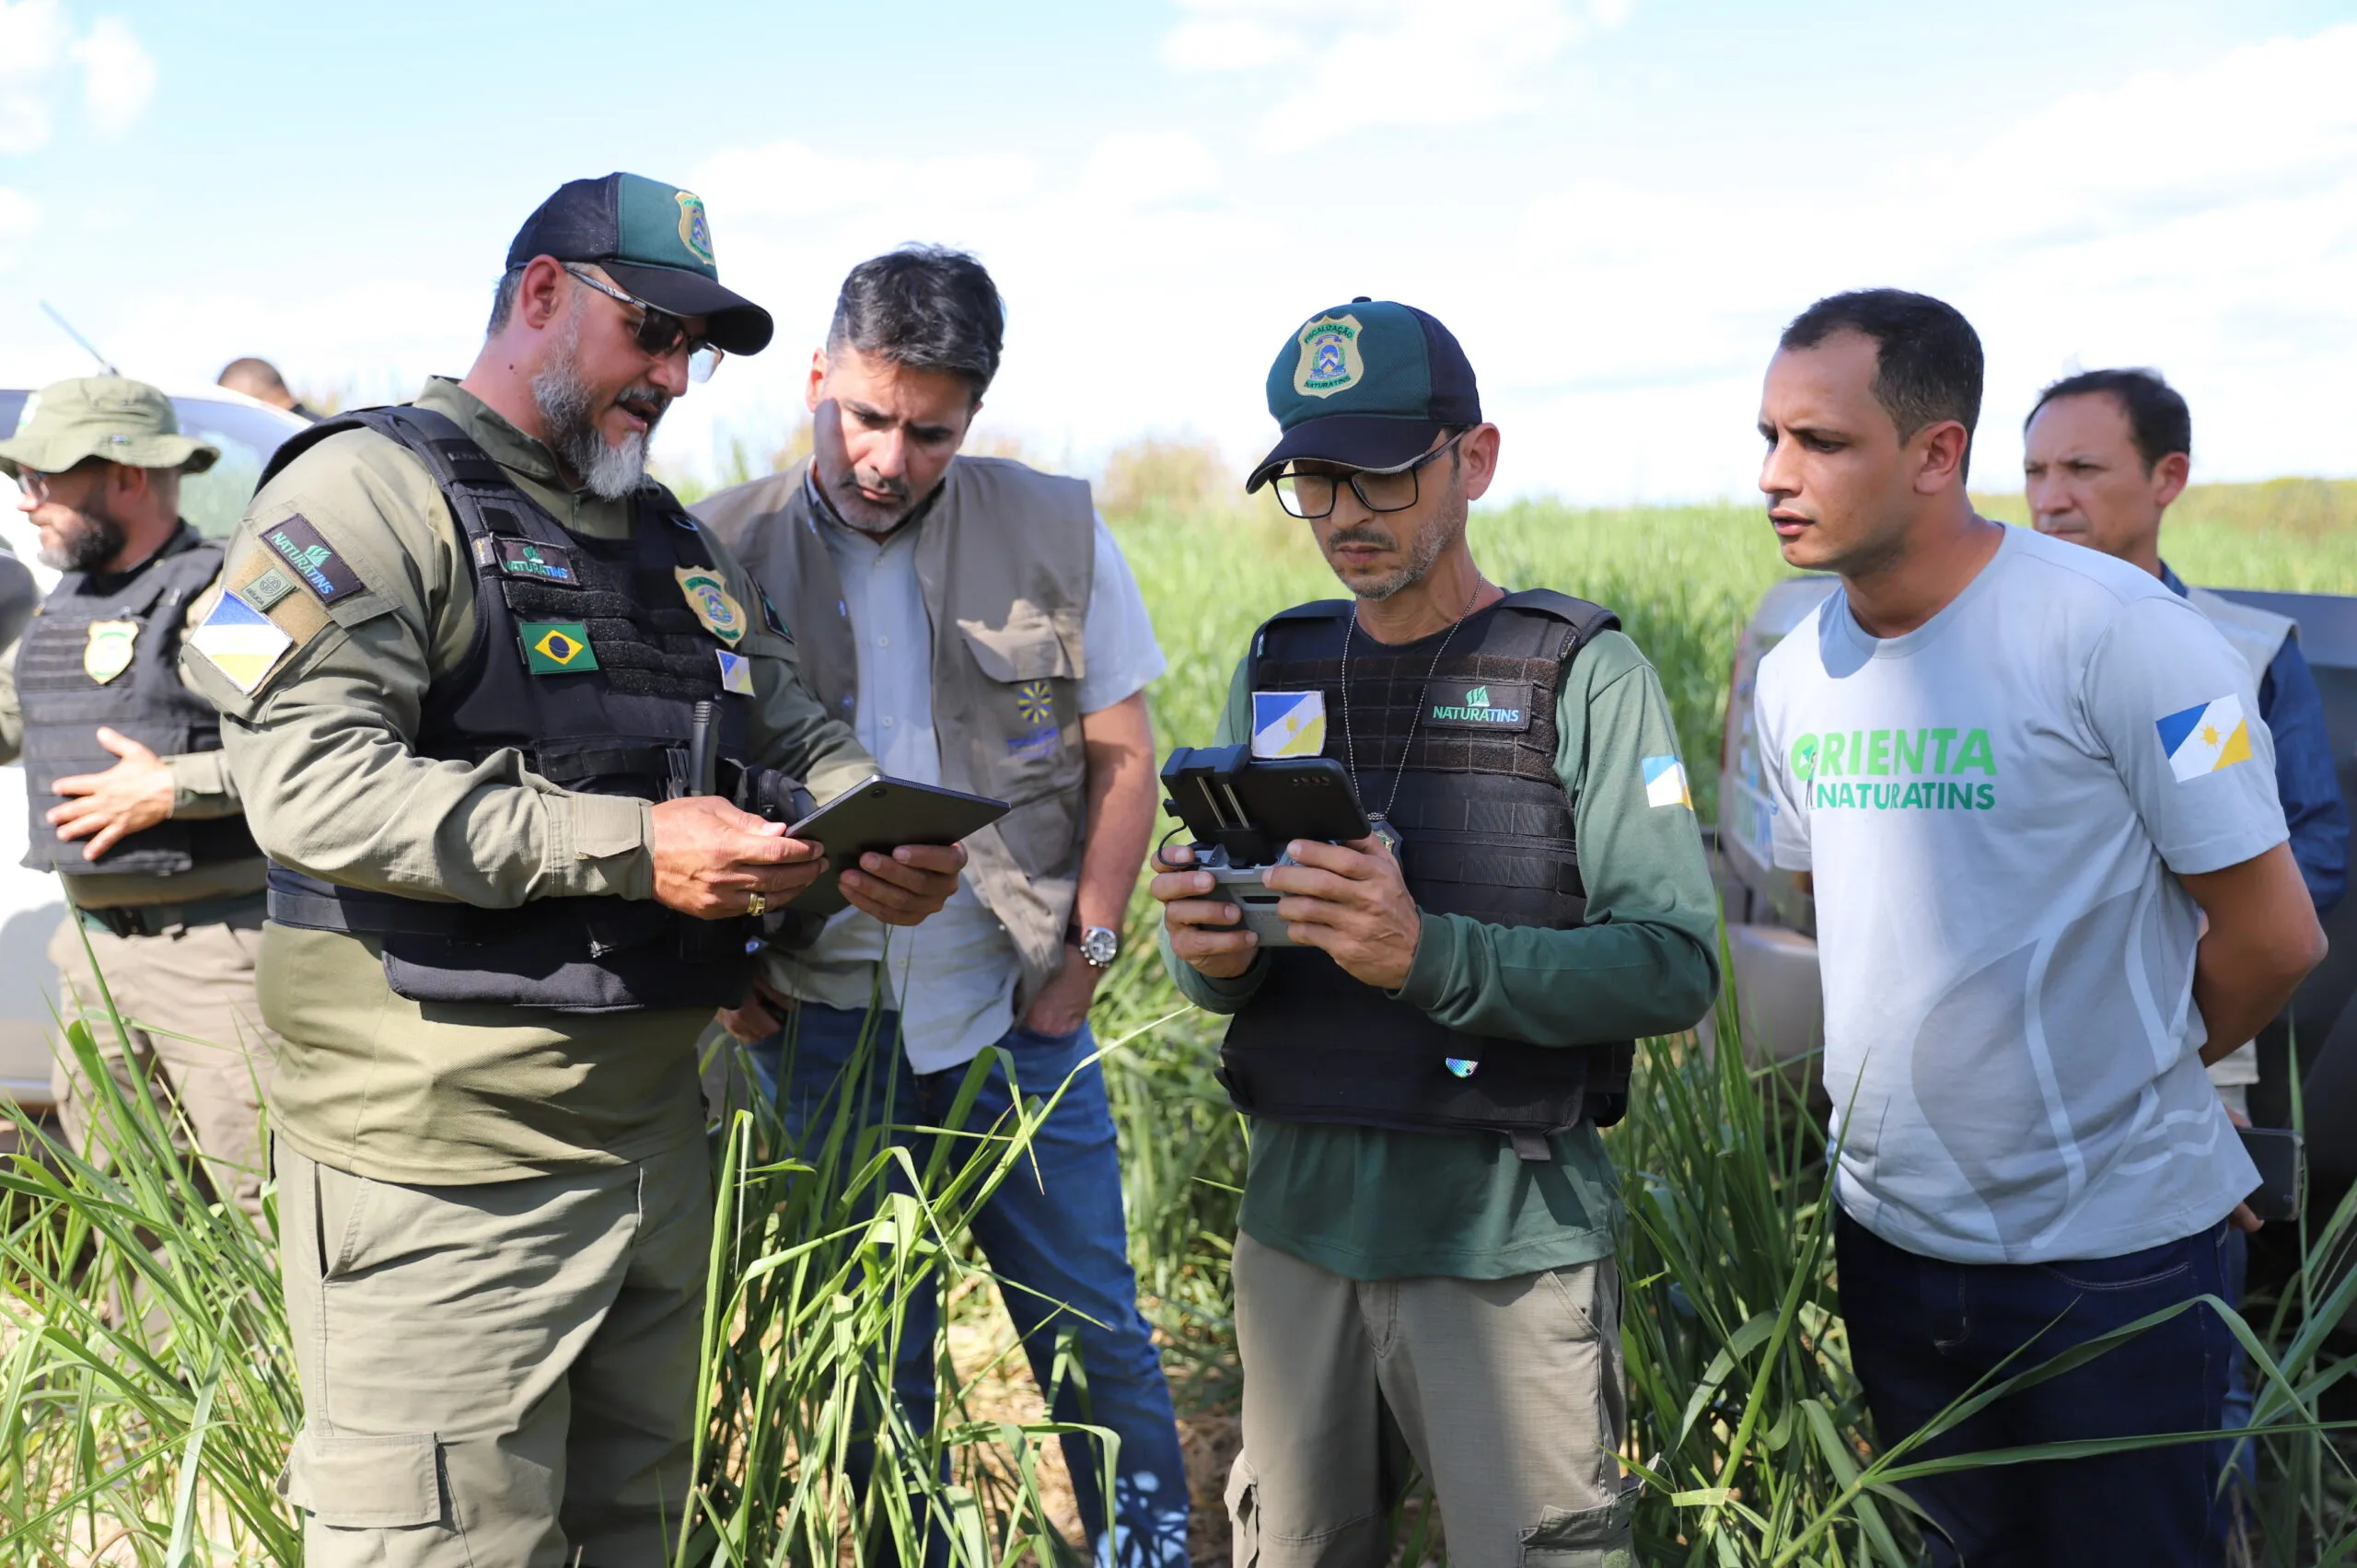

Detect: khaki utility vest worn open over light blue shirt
[691, 458, 1096, 1016]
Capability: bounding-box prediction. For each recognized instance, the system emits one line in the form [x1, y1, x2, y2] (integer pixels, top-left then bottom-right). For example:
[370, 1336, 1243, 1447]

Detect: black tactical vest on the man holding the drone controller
[1219, 589, 1633, 1157]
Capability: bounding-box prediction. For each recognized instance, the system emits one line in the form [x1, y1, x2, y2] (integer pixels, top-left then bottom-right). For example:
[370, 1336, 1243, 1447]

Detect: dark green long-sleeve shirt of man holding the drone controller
[1162, 632, 1718, 1281]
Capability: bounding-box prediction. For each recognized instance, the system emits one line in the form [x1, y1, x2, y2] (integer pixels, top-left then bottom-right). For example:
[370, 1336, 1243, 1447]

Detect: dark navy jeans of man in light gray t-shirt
[1834, 1214, 2235, 1568]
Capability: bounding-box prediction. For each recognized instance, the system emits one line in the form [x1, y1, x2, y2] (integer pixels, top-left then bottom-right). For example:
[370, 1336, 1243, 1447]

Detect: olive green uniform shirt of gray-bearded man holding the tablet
[181, 379, 875, 1184]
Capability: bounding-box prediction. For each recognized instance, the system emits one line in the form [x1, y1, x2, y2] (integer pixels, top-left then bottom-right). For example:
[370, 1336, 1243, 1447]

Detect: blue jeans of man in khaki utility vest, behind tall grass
[745, 1002, 1188, 1568]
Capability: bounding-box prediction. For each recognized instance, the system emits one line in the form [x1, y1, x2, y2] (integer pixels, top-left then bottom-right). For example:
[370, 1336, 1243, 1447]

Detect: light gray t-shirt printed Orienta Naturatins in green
[1756, 528, 2286, 1264]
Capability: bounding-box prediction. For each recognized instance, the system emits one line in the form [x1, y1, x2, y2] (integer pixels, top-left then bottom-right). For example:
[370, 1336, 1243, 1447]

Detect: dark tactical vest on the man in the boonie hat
[17, 524, 261, 896]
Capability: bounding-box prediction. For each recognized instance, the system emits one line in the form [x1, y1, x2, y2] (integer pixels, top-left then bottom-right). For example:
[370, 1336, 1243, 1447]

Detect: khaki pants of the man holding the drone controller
[1228, 1233, 1636, 1568]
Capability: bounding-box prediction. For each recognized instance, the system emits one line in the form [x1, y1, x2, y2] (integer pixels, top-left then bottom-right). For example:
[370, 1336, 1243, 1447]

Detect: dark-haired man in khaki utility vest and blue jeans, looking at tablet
[695, 245, 1188, 1568]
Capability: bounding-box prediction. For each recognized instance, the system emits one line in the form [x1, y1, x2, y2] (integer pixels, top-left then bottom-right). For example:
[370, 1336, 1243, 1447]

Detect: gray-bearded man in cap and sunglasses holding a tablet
[184, 175, 964, 1568]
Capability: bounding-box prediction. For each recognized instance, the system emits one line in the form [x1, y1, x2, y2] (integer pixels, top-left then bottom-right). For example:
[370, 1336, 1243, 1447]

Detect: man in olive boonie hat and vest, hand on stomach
[0, 375, 276, 1216]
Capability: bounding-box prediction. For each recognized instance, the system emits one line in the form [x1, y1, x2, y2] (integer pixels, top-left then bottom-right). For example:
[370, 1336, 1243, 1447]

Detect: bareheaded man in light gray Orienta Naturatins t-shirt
[1754, 290, 2324, 1568]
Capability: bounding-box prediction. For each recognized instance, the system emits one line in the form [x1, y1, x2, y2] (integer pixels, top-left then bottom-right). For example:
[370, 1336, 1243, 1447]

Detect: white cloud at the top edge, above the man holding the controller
[1160, 0, 1631, 148]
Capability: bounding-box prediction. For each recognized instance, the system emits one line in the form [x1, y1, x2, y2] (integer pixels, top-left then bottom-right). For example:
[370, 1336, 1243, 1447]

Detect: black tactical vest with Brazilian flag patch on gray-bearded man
[261, 405, 792, 1012]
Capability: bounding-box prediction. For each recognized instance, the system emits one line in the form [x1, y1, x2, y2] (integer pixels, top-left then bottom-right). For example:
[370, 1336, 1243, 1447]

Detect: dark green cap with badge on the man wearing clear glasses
[1245, 295, 1480, 493]
